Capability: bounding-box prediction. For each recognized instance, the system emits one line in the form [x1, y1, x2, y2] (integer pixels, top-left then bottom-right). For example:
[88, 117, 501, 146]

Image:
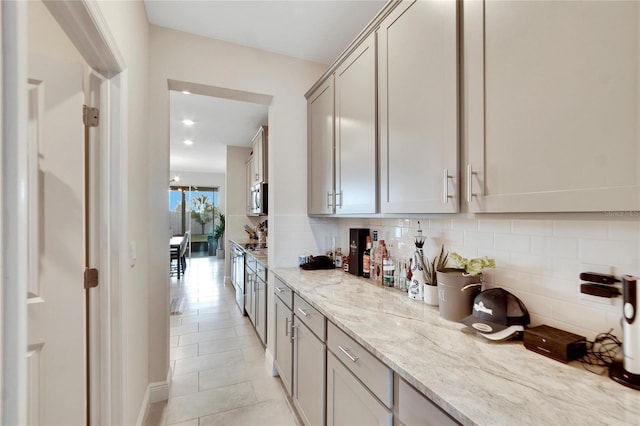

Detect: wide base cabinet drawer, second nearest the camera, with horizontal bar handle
[327, 322, 393, 408]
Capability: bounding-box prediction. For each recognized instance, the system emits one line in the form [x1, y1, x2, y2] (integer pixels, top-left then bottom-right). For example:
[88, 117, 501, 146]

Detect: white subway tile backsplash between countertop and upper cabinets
[336, 216, 640, 339]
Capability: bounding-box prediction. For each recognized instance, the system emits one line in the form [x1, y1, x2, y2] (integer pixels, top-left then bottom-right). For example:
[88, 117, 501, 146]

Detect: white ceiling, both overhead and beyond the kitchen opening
[145, 0, 387, 173]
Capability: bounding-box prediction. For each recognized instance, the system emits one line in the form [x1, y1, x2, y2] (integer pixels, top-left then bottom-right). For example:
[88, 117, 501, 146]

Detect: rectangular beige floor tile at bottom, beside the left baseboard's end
[167, 383, 257, 424]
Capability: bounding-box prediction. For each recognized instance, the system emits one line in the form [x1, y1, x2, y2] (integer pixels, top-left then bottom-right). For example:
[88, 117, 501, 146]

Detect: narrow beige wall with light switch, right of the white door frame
[98, 1, 152, 424]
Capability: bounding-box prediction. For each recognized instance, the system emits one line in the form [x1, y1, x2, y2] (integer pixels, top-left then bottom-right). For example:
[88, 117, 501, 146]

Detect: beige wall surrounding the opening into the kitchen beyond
[149, 26, 326, 362]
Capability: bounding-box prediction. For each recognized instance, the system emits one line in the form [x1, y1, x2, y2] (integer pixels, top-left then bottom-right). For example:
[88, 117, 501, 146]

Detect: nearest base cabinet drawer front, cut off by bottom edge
[395, 376, 460, 426]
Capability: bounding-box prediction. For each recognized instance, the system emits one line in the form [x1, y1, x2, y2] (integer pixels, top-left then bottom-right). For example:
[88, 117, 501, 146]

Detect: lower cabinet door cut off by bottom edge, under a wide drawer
[327, 352, 392, 426]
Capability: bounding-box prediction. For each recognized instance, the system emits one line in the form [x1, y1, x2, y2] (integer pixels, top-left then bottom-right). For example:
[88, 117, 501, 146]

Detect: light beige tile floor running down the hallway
[145, 257, 299, 426]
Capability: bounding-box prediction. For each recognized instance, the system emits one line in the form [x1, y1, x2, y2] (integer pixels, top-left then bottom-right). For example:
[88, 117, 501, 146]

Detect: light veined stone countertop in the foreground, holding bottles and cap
[273, 268, 640, 425]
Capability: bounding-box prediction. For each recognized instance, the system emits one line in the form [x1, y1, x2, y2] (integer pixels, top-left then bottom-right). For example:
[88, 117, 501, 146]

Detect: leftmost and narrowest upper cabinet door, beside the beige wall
[307, 76, 335, 215]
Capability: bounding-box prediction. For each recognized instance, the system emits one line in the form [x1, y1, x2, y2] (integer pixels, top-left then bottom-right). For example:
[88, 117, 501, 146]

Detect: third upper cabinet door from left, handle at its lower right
[378, 0, 459, 213]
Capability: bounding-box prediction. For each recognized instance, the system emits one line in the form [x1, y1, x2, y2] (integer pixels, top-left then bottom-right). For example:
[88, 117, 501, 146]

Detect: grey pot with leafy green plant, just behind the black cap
[436, 253, 496, 321]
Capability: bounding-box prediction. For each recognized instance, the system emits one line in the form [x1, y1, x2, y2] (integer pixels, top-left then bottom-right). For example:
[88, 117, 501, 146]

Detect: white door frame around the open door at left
[0, 0, 128, 424]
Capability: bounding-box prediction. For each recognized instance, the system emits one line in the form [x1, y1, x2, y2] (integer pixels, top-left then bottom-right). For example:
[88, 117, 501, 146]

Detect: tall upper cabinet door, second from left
[335, 34, 377, 214]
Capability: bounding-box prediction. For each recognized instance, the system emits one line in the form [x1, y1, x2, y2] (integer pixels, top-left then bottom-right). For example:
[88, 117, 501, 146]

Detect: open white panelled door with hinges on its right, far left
[25, 56, 87, 425]
